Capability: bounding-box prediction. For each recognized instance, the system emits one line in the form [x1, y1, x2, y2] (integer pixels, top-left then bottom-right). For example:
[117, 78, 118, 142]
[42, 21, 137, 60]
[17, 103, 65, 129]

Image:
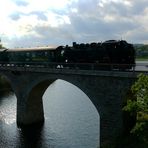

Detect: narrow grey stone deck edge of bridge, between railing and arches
[0, 66, 148, 77]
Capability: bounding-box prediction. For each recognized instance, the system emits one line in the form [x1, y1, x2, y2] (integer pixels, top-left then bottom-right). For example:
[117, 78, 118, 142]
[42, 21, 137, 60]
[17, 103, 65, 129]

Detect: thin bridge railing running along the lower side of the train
[0, 62, 148, 71]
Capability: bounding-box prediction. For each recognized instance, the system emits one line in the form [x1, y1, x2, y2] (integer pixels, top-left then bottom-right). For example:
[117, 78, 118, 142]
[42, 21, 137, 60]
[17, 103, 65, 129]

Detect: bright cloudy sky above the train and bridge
[0, 0, 148, 48]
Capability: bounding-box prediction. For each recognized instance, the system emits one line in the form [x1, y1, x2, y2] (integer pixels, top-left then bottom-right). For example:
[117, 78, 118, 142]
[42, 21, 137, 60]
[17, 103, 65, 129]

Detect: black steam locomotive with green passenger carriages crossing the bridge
[0, 40, 135, 70]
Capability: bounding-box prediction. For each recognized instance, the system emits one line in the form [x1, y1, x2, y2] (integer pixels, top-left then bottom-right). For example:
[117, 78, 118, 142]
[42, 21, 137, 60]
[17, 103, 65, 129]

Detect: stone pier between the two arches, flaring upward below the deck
[3, 71, 55, 127]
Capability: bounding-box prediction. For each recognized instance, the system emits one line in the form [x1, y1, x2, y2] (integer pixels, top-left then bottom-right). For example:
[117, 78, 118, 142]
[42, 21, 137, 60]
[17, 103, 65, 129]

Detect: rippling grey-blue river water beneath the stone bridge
[0, 80, 99, 148]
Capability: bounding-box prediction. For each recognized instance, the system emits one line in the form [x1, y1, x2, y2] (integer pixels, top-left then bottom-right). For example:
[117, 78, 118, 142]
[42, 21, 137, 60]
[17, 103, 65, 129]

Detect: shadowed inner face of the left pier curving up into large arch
[18, 79, 55, 126]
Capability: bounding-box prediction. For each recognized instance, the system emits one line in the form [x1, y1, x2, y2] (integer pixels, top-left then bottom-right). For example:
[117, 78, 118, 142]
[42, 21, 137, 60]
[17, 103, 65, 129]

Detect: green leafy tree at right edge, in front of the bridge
[123, 74, 148, 145]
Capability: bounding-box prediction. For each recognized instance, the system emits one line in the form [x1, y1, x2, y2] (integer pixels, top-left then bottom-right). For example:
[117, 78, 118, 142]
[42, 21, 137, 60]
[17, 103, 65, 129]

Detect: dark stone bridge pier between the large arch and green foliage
[67, 75, 136, 148]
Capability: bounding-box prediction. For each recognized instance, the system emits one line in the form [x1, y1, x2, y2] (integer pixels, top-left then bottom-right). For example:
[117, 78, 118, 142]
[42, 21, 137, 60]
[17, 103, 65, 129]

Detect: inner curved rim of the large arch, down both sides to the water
[27, 77, 100, 145]
